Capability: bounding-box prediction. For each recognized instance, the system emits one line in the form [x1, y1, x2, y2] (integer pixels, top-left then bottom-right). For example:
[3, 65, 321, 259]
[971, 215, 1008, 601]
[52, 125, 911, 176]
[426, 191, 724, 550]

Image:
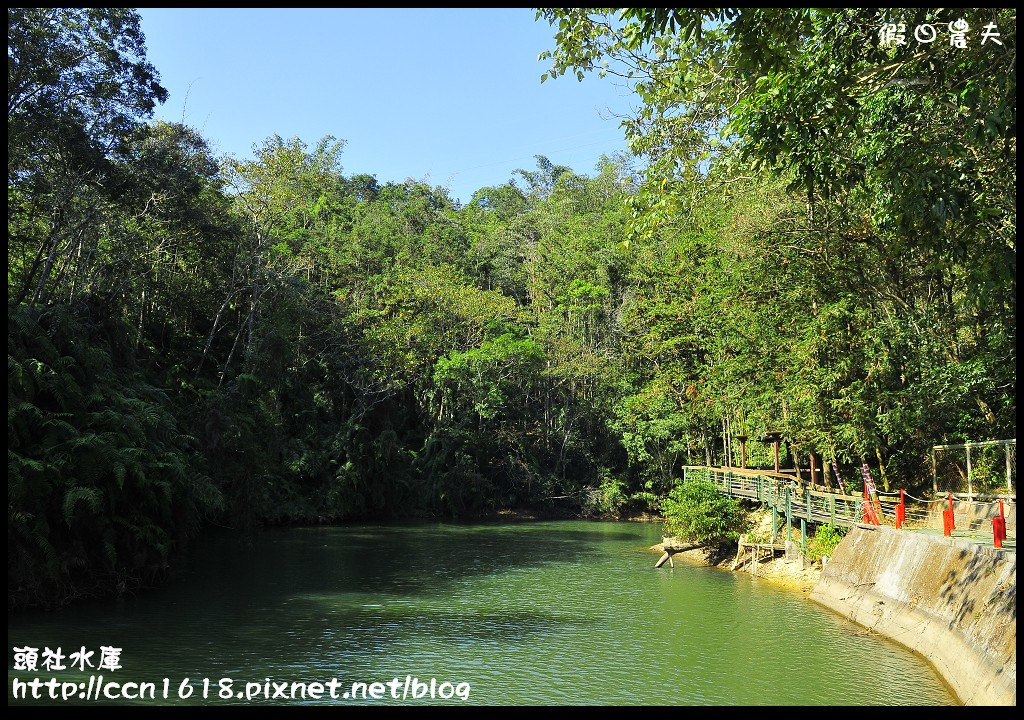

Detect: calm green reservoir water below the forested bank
[7, 521, 955, 705]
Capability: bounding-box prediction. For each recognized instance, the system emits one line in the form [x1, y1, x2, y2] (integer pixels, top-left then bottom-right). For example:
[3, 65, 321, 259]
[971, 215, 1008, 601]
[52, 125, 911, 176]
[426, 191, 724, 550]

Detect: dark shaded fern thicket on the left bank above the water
[7, 307, 222, 606]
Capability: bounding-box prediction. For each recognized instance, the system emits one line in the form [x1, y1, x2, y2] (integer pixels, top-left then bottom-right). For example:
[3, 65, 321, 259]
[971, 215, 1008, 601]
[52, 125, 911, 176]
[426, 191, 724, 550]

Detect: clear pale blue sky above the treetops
[139, 8, 636, 203]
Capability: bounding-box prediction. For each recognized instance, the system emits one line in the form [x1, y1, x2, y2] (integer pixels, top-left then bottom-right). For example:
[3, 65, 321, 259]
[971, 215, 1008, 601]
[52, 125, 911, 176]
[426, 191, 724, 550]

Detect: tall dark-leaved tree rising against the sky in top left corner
[7, 8, 167, 303]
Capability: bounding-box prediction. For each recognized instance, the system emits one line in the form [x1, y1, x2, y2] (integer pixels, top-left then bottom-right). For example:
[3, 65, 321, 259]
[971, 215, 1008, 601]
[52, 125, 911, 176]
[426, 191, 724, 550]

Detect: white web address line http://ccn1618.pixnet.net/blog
[11, 675, 470, 703]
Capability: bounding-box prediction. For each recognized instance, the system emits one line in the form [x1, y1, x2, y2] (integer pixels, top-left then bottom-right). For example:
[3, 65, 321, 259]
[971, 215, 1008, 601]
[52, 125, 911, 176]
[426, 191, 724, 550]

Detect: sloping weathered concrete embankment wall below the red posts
[811, 525, 1017, 705]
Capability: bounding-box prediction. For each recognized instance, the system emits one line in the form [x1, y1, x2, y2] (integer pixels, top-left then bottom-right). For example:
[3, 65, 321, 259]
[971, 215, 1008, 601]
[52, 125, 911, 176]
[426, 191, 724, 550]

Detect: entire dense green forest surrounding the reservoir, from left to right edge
[7, 8, 1016, 607]
